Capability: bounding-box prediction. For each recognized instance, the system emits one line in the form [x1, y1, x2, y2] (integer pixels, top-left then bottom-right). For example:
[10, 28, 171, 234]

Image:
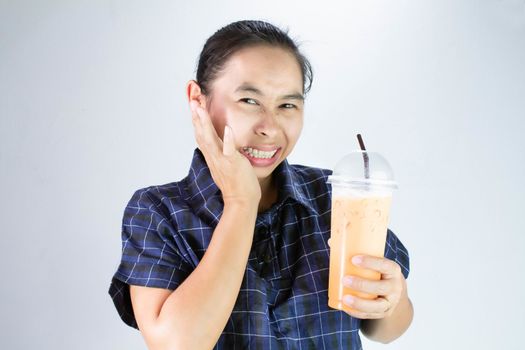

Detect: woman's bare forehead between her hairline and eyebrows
[213, 46, 303, 95]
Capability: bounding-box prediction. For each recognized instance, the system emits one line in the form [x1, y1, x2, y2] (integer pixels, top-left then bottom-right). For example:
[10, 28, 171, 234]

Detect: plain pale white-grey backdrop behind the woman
[0, 0, 525, 349]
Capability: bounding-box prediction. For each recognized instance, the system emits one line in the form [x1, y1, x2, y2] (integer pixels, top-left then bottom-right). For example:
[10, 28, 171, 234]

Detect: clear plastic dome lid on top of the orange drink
[327, 151, 398, 189]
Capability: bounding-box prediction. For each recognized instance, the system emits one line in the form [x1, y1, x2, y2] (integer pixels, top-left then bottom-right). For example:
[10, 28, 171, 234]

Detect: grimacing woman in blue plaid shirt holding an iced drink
[109, 21, 413, 349]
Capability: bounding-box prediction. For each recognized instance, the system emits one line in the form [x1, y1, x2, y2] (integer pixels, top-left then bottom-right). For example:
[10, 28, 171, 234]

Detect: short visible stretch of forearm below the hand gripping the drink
[361, 287, 414, 343]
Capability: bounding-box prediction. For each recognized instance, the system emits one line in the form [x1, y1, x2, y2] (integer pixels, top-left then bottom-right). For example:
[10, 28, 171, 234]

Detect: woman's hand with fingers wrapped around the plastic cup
[343, 255, 406, 319]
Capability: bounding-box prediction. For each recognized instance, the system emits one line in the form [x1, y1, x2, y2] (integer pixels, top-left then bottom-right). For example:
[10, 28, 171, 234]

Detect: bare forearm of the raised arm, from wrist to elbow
[157, 204, 257, 349]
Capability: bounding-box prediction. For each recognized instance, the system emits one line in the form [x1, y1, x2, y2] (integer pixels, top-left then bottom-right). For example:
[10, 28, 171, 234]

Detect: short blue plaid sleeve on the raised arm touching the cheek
[108, 189, 192, 329]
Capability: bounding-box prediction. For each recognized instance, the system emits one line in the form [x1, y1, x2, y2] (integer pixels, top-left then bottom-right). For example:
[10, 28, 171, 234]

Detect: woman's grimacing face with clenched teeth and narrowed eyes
[199, 46, 304, 180]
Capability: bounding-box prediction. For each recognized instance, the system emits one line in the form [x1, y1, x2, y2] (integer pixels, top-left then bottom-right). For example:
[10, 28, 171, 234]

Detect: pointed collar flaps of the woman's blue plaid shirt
[186, 148, 318, 223]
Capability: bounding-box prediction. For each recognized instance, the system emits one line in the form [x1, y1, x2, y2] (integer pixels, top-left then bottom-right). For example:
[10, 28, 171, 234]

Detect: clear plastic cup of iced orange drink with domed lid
[328, 151, 397, 311]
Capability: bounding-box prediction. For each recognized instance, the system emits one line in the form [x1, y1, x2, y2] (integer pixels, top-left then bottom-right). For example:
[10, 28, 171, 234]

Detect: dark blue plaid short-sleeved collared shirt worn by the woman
[109, 149, 409, 350]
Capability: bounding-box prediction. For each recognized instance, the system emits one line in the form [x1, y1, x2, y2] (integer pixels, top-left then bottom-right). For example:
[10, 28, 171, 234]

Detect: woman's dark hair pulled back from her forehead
[197, 21, 313, 95]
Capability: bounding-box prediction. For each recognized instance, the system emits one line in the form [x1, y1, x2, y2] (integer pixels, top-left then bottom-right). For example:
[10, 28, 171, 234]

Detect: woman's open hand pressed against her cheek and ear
[190, 101, 261, 206]
